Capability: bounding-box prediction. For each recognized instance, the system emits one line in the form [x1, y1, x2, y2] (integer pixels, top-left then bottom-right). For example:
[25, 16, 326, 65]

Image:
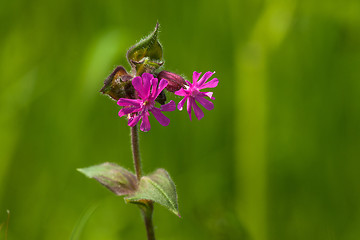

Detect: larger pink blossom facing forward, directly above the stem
[117, 73, 176, 132]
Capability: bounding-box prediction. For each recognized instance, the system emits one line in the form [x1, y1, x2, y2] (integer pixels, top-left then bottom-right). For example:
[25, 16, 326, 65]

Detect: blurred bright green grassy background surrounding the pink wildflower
[0, 0, 360, 240]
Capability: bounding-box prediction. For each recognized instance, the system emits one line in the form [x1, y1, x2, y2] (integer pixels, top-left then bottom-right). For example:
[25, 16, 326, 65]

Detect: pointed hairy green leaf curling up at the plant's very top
[126, 23, 164, 75]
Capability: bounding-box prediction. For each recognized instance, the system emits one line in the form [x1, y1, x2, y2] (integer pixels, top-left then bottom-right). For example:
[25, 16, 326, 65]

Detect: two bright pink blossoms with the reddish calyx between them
[117, 71, 219, 132]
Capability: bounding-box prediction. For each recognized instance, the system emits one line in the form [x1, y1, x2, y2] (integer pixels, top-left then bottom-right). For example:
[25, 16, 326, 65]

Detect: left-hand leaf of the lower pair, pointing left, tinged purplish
[77, 162, 137, 196]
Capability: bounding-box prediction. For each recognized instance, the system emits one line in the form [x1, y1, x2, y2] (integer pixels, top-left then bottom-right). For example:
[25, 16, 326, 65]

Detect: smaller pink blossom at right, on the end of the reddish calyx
[175, 72, 219, 120]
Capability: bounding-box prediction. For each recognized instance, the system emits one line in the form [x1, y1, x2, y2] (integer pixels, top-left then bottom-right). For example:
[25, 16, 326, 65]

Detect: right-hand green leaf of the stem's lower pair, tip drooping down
[125, 169, 180, 217]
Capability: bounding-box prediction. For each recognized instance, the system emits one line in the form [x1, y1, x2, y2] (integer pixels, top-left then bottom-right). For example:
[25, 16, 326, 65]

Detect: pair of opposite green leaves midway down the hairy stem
[78, 162, 180, 217]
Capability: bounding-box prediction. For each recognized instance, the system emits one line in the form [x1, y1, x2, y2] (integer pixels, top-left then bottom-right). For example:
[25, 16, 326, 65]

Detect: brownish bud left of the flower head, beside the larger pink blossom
[100, 66, 134, 100]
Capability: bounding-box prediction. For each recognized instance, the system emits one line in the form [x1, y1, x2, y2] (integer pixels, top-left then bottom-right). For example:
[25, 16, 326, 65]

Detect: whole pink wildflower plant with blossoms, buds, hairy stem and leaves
[78, 24, 219, 240]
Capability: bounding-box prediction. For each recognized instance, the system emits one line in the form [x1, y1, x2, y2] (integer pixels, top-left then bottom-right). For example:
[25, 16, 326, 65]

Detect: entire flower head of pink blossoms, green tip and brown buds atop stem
[100, 23, 219, 132]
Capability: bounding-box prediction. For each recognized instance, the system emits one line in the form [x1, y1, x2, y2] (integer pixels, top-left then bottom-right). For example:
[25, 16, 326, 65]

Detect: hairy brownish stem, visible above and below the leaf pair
[131, 125, 155, 240]
